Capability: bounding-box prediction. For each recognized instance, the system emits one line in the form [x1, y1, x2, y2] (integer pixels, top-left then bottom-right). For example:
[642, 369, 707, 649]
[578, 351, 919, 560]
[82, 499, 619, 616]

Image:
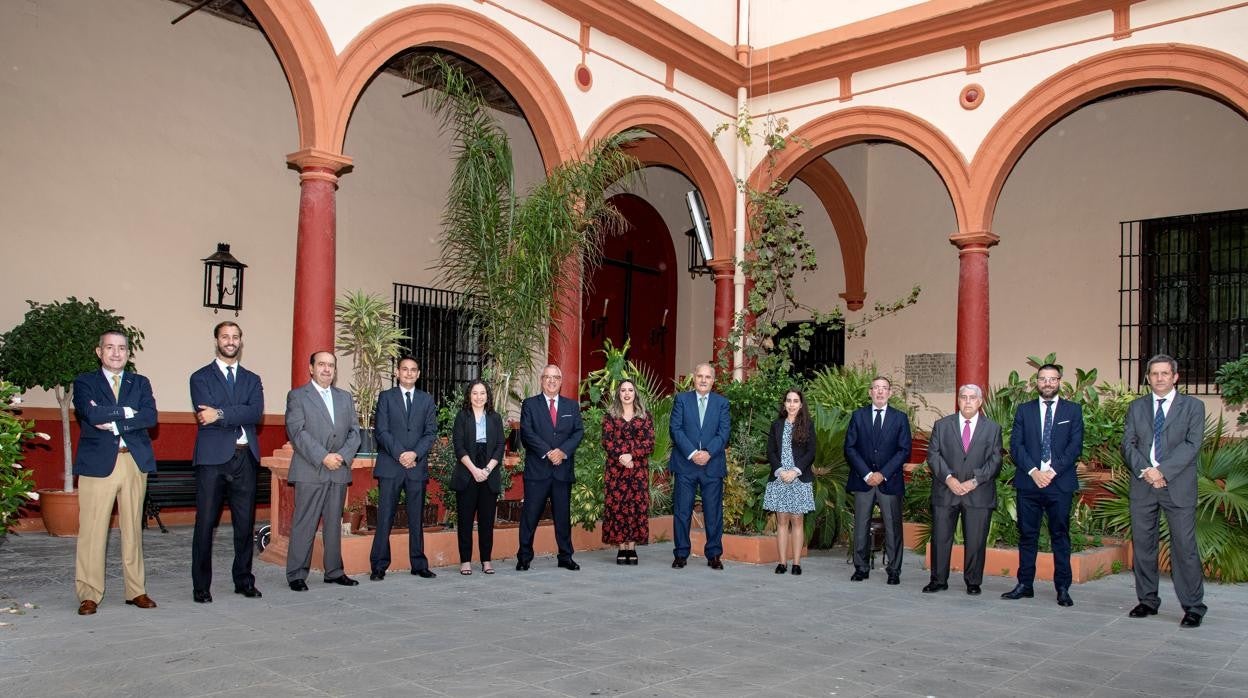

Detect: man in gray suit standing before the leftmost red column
[286, 351, 359, 592]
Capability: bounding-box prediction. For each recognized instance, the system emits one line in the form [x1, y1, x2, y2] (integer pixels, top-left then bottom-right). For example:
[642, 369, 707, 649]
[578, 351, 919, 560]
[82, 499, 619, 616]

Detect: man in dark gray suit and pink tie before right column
[924, 385, 1001, 596]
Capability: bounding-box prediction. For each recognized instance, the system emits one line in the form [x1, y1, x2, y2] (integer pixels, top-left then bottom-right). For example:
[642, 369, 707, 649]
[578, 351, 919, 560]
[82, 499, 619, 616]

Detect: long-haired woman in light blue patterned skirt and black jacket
[763, 388, 815, 574]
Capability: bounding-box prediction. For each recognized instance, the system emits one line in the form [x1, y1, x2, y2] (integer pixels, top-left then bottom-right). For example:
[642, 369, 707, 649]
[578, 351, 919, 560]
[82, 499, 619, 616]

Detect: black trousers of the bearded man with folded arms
[191, 448, 256, 592]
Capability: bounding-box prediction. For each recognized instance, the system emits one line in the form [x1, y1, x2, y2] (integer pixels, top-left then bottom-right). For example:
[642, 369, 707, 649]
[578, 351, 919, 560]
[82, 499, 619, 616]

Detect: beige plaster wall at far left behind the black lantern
[0, 0, 300, 413]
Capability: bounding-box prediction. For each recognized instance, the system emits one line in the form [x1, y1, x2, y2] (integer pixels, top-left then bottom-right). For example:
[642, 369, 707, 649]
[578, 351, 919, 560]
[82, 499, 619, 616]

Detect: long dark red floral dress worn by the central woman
[603, 415, 654, 546]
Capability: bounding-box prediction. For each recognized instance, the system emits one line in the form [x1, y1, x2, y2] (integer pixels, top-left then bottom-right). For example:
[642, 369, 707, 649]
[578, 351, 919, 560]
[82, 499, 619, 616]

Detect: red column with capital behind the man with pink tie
[948, 231, 1001, 392]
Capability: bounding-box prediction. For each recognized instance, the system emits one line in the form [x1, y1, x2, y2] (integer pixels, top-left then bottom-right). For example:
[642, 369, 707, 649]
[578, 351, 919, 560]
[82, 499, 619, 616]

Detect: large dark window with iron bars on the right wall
[1118, 209, 1248, 395]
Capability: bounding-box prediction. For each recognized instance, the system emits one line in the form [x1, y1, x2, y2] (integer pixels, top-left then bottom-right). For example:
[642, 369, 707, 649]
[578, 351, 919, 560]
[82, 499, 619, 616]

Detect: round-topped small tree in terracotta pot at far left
[0, 296, 144, 536]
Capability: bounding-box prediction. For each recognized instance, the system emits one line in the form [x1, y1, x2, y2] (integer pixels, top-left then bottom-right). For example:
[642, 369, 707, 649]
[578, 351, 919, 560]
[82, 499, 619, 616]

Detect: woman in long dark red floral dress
[603, 381, 654, 564]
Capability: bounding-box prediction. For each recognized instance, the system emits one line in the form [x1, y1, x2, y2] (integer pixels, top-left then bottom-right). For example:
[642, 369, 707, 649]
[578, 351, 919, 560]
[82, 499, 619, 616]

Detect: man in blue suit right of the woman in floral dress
[668, 363, 733, 569]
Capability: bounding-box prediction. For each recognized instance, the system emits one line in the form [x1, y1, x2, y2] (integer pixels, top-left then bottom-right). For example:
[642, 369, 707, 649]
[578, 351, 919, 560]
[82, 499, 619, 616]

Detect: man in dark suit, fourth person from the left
[368, 356, 438, 582]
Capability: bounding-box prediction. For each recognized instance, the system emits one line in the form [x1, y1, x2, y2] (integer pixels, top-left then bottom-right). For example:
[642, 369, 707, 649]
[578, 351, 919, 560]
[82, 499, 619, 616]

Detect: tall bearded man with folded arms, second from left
[191, 320, 265, 603]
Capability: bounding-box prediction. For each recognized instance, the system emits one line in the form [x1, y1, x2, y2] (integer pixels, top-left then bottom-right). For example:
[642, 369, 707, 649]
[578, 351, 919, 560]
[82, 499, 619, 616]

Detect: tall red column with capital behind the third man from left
[287, 149, 351, 387]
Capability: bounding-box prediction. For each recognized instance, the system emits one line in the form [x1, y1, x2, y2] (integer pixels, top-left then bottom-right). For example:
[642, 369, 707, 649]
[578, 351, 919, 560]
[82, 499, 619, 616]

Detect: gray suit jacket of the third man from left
[286, 381, 359, 484]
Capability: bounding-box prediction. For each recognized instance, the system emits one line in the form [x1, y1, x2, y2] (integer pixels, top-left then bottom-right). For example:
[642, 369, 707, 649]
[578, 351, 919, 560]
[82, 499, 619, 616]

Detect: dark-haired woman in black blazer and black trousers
[451, 381, 503, 574]
